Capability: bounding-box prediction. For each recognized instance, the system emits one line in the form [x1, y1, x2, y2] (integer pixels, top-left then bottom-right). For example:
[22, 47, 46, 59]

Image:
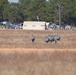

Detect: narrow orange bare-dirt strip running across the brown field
[0, 48, 76, 53]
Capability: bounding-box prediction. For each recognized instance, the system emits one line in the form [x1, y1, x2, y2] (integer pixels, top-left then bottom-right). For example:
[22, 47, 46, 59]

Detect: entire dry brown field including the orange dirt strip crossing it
[0, 30, 76, 75]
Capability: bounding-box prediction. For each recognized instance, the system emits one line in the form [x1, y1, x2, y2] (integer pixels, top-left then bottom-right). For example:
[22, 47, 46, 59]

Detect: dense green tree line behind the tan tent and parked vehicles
[0, 0, 76, 25]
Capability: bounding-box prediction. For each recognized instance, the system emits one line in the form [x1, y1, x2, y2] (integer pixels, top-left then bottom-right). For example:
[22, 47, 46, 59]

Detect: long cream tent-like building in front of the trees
[23, 21, 45, 30]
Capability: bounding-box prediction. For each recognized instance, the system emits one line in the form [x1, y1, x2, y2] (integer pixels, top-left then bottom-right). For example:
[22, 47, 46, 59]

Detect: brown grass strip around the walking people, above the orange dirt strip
[0, 30, 76, 49]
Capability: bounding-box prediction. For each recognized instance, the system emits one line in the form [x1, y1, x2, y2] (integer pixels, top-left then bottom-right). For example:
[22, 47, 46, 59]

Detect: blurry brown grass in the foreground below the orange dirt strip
[0, 51, 76, 75]
